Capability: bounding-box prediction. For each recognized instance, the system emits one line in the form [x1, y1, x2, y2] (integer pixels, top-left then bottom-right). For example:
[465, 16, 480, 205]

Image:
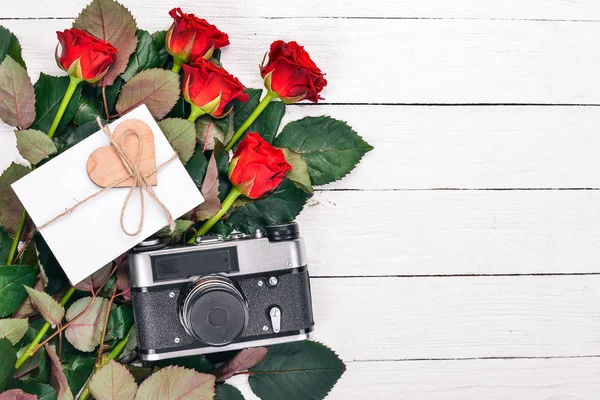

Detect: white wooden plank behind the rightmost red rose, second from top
[4, 18, 600, 104]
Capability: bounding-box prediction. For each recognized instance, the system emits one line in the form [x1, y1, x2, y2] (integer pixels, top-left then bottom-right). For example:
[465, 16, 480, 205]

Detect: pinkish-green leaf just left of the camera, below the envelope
[65, 297, 108, 352]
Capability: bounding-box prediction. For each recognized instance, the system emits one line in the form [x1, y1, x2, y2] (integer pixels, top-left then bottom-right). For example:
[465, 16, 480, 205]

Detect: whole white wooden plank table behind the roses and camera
[0, 0, 600, 400]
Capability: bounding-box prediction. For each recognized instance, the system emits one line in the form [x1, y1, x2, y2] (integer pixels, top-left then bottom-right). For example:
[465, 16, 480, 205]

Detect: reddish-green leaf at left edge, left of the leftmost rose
[0, 56, 35, 129]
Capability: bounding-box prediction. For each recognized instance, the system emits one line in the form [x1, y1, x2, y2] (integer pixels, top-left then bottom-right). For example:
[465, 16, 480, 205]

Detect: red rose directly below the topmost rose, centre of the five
[183, 58, 248, 117]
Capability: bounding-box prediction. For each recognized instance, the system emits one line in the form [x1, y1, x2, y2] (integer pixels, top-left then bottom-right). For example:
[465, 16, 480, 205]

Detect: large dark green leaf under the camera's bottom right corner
[249, 341, 346, 400]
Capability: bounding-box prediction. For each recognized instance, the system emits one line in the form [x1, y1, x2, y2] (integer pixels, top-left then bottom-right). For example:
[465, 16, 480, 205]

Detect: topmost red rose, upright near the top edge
[165, 8, 229, 63]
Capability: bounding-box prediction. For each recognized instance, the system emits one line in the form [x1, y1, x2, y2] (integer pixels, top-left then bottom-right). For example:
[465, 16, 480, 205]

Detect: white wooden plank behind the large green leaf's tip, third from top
[282, 105, 600, 190]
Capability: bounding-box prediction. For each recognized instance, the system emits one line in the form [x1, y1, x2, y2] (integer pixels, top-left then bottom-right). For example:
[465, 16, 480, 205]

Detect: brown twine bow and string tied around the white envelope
[38, 117, 177, 236]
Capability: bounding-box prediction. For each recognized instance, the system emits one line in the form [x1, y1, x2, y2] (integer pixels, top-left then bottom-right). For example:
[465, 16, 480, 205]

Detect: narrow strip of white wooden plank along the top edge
[1, 0, 600, 20]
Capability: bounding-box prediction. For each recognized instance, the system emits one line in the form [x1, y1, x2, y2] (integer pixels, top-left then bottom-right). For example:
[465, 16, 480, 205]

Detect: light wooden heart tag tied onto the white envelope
[86, 119, 156, 187]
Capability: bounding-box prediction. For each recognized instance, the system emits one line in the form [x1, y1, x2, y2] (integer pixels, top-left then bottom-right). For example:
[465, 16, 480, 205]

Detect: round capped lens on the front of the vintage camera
[180, 276, 248, 346]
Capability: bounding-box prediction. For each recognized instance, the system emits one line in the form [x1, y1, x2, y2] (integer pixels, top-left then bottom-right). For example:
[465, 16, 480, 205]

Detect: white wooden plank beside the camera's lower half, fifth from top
[311, 276, 600, 361]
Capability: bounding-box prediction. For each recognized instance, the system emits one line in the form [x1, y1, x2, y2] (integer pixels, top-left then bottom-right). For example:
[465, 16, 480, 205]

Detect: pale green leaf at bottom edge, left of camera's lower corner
[90, 360, 137, 400]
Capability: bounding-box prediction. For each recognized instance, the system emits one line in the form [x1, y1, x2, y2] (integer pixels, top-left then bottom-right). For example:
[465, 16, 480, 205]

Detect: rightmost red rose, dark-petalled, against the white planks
[261, 40, 327, 103]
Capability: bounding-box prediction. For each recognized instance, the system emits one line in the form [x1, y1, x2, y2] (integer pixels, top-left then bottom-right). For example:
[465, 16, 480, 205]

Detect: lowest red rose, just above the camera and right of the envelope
[229, 132, 292, 199]
